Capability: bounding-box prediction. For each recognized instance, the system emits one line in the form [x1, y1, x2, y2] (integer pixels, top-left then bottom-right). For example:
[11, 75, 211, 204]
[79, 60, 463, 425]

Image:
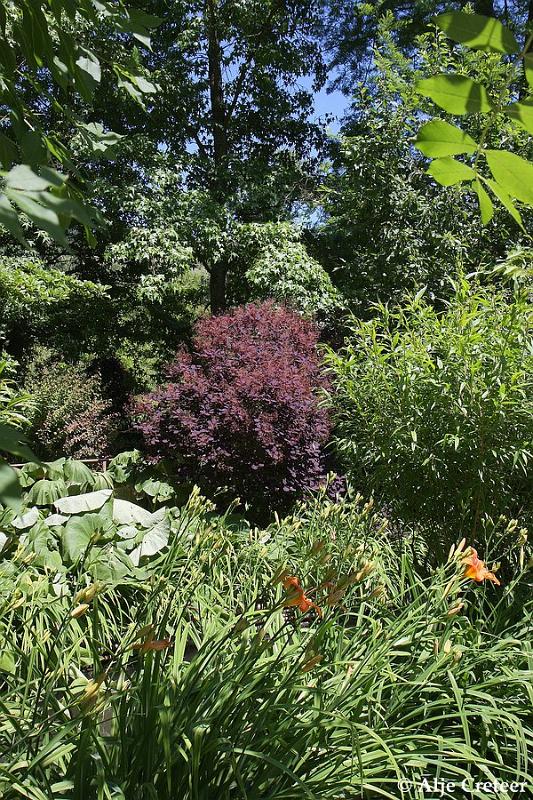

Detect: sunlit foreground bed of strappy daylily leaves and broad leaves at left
[0, 459, 533, 800]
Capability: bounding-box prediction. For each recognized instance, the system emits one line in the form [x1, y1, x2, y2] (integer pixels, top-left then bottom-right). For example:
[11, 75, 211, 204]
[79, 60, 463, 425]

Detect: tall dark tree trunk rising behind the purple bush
[206, 0, 228, 314]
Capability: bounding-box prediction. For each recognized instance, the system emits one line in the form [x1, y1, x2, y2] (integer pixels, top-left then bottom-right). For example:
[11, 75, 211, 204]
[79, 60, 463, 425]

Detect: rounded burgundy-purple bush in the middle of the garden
[137, 302, 330, 511]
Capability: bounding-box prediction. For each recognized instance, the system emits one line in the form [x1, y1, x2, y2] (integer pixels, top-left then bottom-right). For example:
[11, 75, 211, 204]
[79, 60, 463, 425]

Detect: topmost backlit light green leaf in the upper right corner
[435, 11, 520, 55]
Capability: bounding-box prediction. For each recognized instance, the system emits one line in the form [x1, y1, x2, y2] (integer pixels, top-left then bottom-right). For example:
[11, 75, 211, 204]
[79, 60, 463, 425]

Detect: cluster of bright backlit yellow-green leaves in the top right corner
[415, 11, 533, 227]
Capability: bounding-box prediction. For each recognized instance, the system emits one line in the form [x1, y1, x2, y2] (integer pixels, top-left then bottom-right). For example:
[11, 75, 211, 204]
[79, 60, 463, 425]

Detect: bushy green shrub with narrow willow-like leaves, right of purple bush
[327, 279, 533, 536]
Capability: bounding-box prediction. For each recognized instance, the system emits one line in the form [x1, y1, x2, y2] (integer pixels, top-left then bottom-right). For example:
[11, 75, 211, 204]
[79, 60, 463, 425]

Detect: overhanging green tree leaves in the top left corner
[0, 0, 159, 246]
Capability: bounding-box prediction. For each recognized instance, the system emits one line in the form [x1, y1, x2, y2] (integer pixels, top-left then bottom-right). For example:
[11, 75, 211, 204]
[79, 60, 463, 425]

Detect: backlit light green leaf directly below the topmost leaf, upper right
[416, 75, 492, 115]
